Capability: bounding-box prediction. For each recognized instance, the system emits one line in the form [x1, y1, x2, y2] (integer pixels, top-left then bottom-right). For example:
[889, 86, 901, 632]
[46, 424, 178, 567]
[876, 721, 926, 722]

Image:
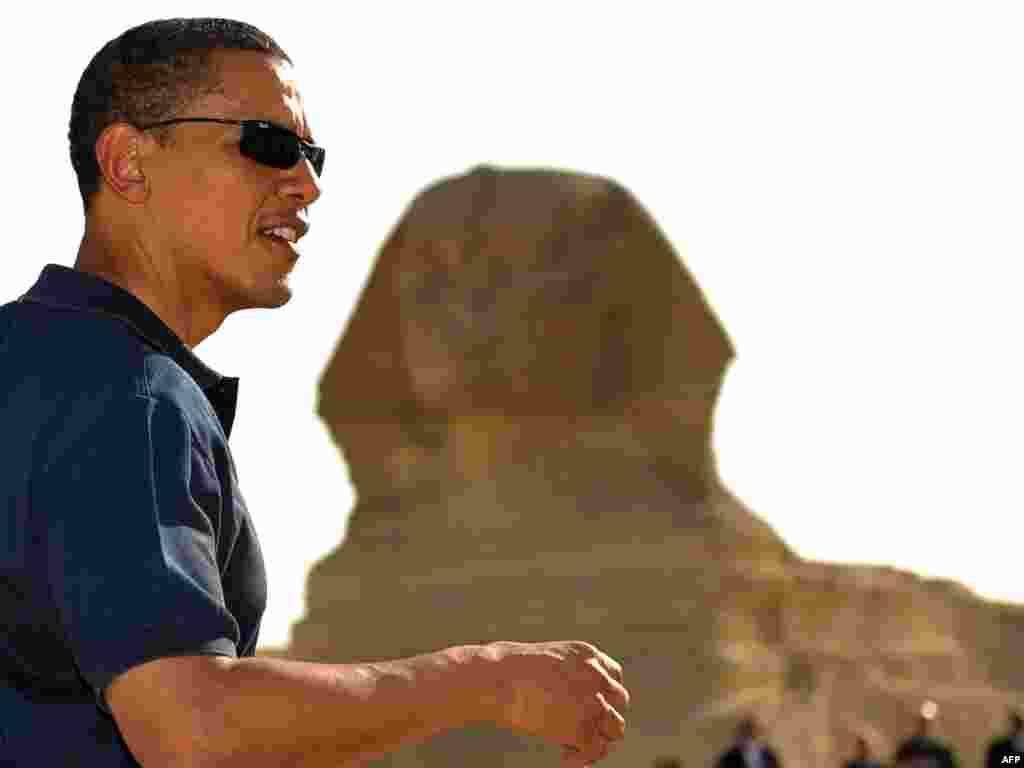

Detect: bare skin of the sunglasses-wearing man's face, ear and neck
[75, 50, 321, 347]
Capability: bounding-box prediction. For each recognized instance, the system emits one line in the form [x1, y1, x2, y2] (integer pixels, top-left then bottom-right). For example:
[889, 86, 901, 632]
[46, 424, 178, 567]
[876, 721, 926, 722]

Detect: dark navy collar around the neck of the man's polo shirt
[20, 264, 239, 435]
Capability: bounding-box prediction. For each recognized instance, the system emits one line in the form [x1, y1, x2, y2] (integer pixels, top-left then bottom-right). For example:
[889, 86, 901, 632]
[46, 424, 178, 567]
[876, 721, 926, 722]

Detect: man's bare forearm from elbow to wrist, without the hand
[200, 645, 500, 768]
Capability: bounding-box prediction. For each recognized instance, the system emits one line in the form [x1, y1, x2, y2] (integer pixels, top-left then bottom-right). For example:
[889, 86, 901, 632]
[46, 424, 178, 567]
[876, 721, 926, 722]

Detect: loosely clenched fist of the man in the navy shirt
[485, 640, 630, 766]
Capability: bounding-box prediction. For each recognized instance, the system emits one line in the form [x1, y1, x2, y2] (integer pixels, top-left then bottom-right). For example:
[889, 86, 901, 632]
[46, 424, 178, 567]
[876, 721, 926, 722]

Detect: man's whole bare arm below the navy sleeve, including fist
[108, 643, 629, 768]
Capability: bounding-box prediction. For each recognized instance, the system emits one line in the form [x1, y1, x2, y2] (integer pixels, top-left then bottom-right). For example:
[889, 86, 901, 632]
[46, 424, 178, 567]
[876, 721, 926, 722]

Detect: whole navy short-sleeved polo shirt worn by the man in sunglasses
[0, 264, 266, 768]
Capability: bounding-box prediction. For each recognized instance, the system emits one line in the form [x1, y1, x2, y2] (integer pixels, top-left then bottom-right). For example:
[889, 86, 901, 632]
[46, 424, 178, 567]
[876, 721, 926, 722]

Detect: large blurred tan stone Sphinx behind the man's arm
[290, 168, 1024, 768]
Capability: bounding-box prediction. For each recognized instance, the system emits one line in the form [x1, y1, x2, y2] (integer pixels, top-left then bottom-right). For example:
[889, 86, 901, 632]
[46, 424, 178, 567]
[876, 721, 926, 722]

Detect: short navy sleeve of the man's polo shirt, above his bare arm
[40, 396, 239, 712]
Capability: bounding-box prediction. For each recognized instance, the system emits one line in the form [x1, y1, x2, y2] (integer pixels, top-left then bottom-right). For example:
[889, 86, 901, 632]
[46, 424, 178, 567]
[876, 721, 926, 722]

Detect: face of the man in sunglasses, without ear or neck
[138, 50, 319, 312]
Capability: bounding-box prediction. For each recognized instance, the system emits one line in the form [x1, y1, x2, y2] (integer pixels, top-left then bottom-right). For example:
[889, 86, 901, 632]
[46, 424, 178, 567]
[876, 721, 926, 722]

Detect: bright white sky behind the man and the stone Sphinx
[6, 0, 1024, 645]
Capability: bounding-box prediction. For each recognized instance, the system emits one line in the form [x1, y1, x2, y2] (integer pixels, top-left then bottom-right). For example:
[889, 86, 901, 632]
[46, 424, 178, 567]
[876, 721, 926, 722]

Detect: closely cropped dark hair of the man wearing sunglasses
[68, 18, 292, 213]
